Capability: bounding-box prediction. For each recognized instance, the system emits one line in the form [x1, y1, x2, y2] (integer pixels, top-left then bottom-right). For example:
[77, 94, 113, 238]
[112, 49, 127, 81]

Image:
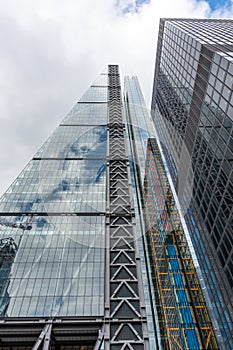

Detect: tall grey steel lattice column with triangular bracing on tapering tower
[105, 66, 149, 350]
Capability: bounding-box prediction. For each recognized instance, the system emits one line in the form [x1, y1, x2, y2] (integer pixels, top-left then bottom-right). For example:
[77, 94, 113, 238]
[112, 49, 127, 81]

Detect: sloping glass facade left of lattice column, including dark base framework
[0, 72, 108, 350]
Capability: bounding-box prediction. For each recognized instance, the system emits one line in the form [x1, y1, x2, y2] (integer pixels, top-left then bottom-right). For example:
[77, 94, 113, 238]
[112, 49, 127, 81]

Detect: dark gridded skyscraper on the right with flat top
[152, 19, 233, 349]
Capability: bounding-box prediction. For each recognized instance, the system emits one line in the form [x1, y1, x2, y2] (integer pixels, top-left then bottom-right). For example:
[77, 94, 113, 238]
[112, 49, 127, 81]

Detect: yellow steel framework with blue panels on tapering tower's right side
[144, 138, 218, 350]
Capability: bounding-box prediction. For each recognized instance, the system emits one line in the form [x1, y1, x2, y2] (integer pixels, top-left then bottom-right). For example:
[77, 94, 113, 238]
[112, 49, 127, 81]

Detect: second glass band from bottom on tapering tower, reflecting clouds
[0, 160, 106, 212]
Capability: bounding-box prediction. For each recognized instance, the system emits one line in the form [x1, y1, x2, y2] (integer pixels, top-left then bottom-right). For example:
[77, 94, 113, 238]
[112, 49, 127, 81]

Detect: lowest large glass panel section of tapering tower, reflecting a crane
[0, 216, 105, 316]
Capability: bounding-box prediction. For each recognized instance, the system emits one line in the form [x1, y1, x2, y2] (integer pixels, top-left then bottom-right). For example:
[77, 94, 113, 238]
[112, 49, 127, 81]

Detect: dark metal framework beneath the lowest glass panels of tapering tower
[0, 317, 103, 350]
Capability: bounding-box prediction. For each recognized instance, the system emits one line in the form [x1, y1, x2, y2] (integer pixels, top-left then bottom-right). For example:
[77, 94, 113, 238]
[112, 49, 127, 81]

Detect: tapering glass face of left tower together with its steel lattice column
[0, 66, 152, 350]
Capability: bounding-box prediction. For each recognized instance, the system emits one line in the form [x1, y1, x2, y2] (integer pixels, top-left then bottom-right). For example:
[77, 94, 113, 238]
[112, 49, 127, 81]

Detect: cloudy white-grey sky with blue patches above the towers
[0, 0, 233, 195]
